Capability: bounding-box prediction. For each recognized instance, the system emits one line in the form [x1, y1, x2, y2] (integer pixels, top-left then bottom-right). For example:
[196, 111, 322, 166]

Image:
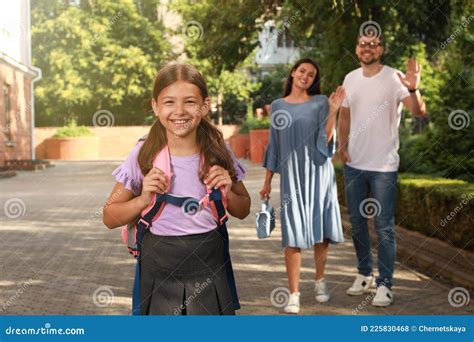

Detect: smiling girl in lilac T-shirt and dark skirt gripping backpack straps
[104, 64, 250, 315]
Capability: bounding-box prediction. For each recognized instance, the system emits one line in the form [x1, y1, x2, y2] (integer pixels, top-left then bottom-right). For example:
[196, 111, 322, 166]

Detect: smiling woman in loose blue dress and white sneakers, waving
[260, 58, 345, 313]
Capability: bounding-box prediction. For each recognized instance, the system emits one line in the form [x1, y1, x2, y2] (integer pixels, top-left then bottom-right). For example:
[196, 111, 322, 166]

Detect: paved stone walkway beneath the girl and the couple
[0, 161, 474, 315]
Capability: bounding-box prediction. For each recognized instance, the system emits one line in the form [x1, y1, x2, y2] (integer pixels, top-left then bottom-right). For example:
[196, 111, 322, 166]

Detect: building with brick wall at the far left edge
[0, 0, 41, 166]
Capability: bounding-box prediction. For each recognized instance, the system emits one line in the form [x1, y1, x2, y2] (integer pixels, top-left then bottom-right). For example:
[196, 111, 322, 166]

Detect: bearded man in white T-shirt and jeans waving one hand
[338, 35, 426, 306]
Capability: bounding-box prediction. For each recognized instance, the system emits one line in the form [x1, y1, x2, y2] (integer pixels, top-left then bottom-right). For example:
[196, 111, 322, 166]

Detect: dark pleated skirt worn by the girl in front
[140, 230, 235, 315]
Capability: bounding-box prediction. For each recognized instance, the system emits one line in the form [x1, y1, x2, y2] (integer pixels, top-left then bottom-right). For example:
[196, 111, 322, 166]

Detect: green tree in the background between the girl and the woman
[172, 0, 266, 124]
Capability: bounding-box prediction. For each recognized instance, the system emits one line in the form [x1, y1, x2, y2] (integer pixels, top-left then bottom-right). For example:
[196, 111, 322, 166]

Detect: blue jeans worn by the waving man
[344, 165, 397, 288]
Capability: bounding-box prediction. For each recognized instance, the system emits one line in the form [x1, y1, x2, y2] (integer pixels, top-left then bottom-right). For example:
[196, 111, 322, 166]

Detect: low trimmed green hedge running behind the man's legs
[336, 165, 474, 250]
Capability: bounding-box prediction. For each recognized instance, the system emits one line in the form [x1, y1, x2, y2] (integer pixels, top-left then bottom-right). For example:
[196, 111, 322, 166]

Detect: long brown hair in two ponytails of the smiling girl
[138, 63, 236, 181]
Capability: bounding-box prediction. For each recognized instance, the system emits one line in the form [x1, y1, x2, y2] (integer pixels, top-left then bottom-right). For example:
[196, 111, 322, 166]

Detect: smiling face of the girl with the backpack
[152, 81, 210, 137]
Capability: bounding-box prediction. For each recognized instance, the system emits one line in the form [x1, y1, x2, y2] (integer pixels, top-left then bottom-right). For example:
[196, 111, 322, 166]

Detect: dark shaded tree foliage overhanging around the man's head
[278, 0, 449, 94]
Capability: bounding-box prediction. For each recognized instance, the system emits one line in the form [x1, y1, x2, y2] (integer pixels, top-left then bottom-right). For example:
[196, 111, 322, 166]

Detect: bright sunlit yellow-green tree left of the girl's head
[32, 0, 170, 126]
